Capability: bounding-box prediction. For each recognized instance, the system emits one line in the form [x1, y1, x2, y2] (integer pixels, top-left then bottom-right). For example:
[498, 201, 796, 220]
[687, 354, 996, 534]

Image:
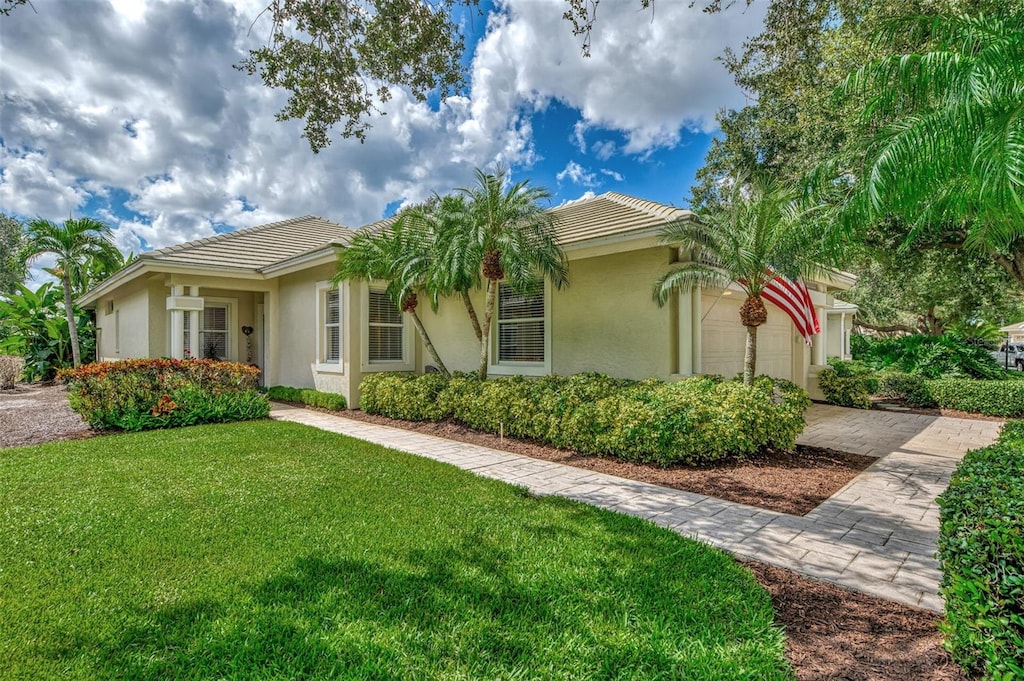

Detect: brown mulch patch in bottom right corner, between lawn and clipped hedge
[743, 561, 968, 681]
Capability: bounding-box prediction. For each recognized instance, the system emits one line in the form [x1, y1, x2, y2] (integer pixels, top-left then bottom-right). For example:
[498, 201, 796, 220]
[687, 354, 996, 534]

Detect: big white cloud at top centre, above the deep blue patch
[474, 0, 766, 154]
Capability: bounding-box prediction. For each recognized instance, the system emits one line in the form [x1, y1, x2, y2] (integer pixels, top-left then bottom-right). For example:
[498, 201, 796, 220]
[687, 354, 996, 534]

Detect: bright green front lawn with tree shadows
[0, 421, 793, 679]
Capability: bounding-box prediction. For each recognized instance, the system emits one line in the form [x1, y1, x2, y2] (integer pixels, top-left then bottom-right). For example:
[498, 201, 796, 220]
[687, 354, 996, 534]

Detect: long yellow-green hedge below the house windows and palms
[360, 374, 810, 466]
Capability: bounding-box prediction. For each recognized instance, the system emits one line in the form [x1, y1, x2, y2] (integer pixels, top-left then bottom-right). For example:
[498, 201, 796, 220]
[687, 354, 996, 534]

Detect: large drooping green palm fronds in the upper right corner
[844, 9, 1024, 250]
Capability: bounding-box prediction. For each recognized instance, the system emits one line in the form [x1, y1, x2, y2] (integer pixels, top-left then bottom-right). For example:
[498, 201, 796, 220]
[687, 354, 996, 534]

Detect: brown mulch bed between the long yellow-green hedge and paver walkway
[342, 411, 877, 515]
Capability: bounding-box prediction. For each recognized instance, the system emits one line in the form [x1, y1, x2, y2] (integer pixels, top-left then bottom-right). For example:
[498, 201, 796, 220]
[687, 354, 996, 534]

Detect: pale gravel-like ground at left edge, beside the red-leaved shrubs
[0, 383, 92, 449]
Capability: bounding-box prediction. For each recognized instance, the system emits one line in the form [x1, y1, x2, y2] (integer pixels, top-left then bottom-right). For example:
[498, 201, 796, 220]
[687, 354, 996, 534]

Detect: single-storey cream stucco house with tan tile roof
[80, 193, 856, 407]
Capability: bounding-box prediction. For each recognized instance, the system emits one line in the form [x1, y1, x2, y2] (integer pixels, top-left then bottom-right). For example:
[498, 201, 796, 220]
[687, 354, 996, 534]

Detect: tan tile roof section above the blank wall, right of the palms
[551, 191, 694, 246]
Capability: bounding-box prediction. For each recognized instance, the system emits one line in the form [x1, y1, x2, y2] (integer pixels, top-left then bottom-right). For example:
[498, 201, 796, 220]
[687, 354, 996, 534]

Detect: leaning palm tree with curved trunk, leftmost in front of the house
[332, 210, 450, 376]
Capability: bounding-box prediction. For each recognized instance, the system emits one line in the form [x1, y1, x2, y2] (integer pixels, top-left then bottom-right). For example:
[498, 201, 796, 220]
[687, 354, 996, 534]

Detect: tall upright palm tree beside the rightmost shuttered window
[438, 167, 568, 380]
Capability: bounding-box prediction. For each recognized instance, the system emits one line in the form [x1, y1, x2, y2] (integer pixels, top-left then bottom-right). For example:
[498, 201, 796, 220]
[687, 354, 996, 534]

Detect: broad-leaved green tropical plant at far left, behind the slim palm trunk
[0, 282, 95, 381]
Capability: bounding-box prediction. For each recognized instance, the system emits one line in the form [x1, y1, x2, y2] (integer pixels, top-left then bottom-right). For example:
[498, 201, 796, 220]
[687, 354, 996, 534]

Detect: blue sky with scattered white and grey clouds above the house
[0, 0, 766, 264]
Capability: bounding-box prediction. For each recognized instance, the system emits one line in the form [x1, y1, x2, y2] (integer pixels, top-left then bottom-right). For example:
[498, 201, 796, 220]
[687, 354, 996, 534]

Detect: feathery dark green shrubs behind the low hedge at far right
[850, 334, 1007, 380]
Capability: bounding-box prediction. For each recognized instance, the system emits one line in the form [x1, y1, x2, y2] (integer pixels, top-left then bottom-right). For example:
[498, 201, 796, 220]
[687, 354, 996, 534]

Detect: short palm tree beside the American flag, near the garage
[654, 178, 824, 385]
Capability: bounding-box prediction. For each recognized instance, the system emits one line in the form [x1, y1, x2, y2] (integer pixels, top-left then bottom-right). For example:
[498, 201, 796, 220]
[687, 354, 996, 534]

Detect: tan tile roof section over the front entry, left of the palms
[140, 215, 353, 269]
